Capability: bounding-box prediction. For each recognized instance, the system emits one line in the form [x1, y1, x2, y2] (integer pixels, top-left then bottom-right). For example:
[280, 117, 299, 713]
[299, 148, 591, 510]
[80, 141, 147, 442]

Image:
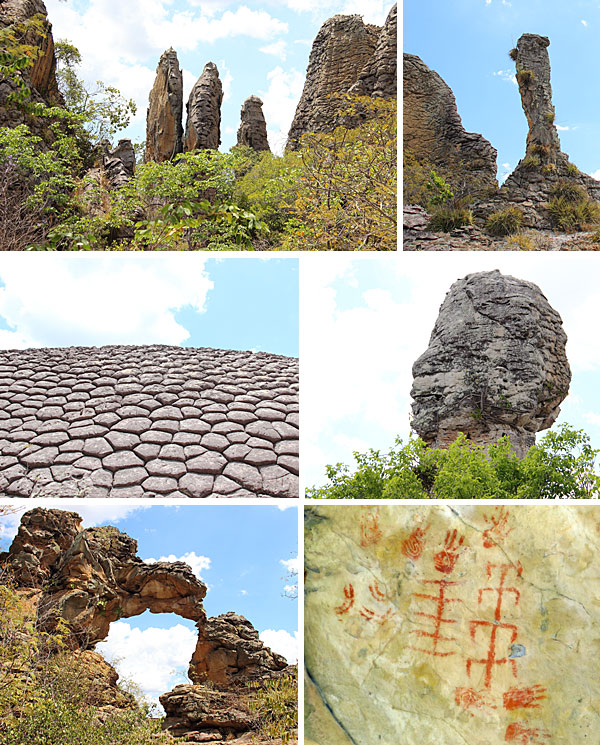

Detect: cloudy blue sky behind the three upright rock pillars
[46, 0, 393, 151]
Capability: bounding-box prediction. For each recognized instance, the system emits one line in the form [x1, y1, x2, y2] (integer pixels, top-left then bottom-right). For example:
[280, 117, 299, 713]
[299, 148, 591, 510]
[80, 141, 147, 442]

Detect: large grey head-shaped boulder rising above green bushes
[411, 270, 571, 456]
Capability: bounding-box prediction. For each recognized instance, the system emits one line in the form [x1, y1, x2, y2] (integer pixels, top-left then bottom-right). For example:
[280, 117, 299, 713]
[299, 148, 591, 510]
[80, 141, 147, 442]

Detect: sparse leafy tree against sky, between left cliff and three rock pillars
[55, 39, 137, 142]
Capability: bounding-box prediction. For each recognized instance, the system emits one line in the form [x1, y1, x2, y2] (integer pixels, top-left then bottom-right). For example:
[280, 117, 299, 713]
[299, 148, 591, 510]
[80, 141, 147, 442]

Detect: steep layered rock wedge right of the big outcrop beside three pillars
[348, 5, 398, 98]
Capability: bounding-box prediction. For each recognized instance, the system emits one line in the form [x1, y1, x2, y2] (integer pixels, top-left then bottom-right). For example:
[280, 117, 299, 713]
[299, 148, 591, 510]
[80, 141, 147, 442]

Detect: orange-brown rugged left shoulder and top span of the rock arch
[3, 508, 206, 649]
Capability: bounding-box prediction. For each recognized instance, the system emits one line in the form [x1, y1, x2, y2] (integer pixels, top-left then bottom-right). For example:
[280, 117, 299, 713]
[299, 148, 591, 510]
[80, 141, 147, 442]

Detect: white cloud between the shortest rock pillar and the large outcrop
[259, 66, 304, 153]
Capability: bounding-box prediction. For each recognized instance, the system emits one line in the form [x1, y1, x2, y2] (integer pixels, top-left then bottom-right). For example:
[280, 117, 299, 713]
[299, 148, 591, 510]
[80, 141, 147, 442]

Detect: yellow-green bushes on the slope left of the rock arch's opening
[0, 575, 169, 744]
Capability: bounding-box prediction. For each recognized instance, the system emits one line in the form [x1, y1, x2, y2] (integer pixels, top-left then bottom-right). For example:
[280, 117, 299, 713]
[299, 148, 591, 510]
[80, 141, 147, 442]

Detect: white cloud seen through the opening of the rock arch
[97, 621, 196, 704]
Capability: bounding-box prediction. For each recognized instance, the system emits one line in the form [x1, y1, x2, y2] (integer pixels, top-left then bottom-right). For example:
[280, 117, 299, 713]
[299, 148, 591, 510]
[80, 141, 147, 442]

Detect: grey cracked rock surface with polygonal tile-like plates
[0, 345, 298, 497]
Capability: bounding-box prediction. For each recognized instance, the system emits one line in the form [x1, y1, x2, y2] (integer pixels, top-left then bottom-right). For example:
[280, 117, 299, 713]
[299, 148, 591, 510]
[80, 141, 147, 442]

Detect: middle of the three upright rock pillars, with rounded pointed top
[184, 62, 223, 152]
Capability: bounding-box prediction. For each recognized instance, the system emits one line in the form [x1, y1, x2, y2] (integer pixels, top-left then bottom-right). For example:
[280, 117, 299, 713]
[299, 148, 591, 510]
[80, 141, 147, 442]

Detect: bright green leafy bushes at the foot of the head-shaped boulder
[306, 425, 600, 500]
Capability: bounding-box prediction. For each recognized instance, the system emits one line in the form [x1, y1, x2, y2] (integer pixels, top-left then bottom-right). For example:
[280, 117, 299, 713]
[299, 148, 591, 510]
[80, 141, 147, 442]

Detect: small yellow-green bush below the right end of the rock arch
[248, 676, 298, 743]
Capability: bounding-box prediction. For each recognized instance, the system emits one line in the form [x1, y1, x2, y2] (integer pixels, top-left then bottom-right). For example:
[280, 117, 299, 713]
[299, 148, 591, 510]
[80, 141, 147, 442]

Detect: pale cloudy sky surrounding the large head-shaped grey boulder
[300, 252, 600, 486]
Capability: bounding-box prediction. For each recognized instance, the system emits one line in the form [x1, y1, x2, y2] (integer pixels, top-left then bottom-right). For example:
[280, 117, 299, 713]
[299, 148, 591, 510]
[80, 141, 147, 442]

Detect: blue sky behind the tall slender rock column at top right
[403, 0, 600, 182]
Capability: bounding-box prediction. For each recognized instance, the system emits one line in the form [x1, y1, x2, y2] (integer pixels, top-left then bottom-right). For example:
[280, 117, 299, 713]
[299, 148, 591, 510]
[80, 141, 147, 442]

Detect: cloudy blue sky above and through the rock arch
[0, 501, 298, 702]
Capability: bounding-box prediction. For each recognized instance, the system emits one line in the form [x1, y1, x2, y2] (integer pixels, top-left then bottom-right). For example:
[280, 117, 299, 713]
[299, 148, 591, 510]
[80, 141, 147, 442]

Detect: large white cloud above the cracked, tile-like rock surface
[0, 253, 213, 349]
